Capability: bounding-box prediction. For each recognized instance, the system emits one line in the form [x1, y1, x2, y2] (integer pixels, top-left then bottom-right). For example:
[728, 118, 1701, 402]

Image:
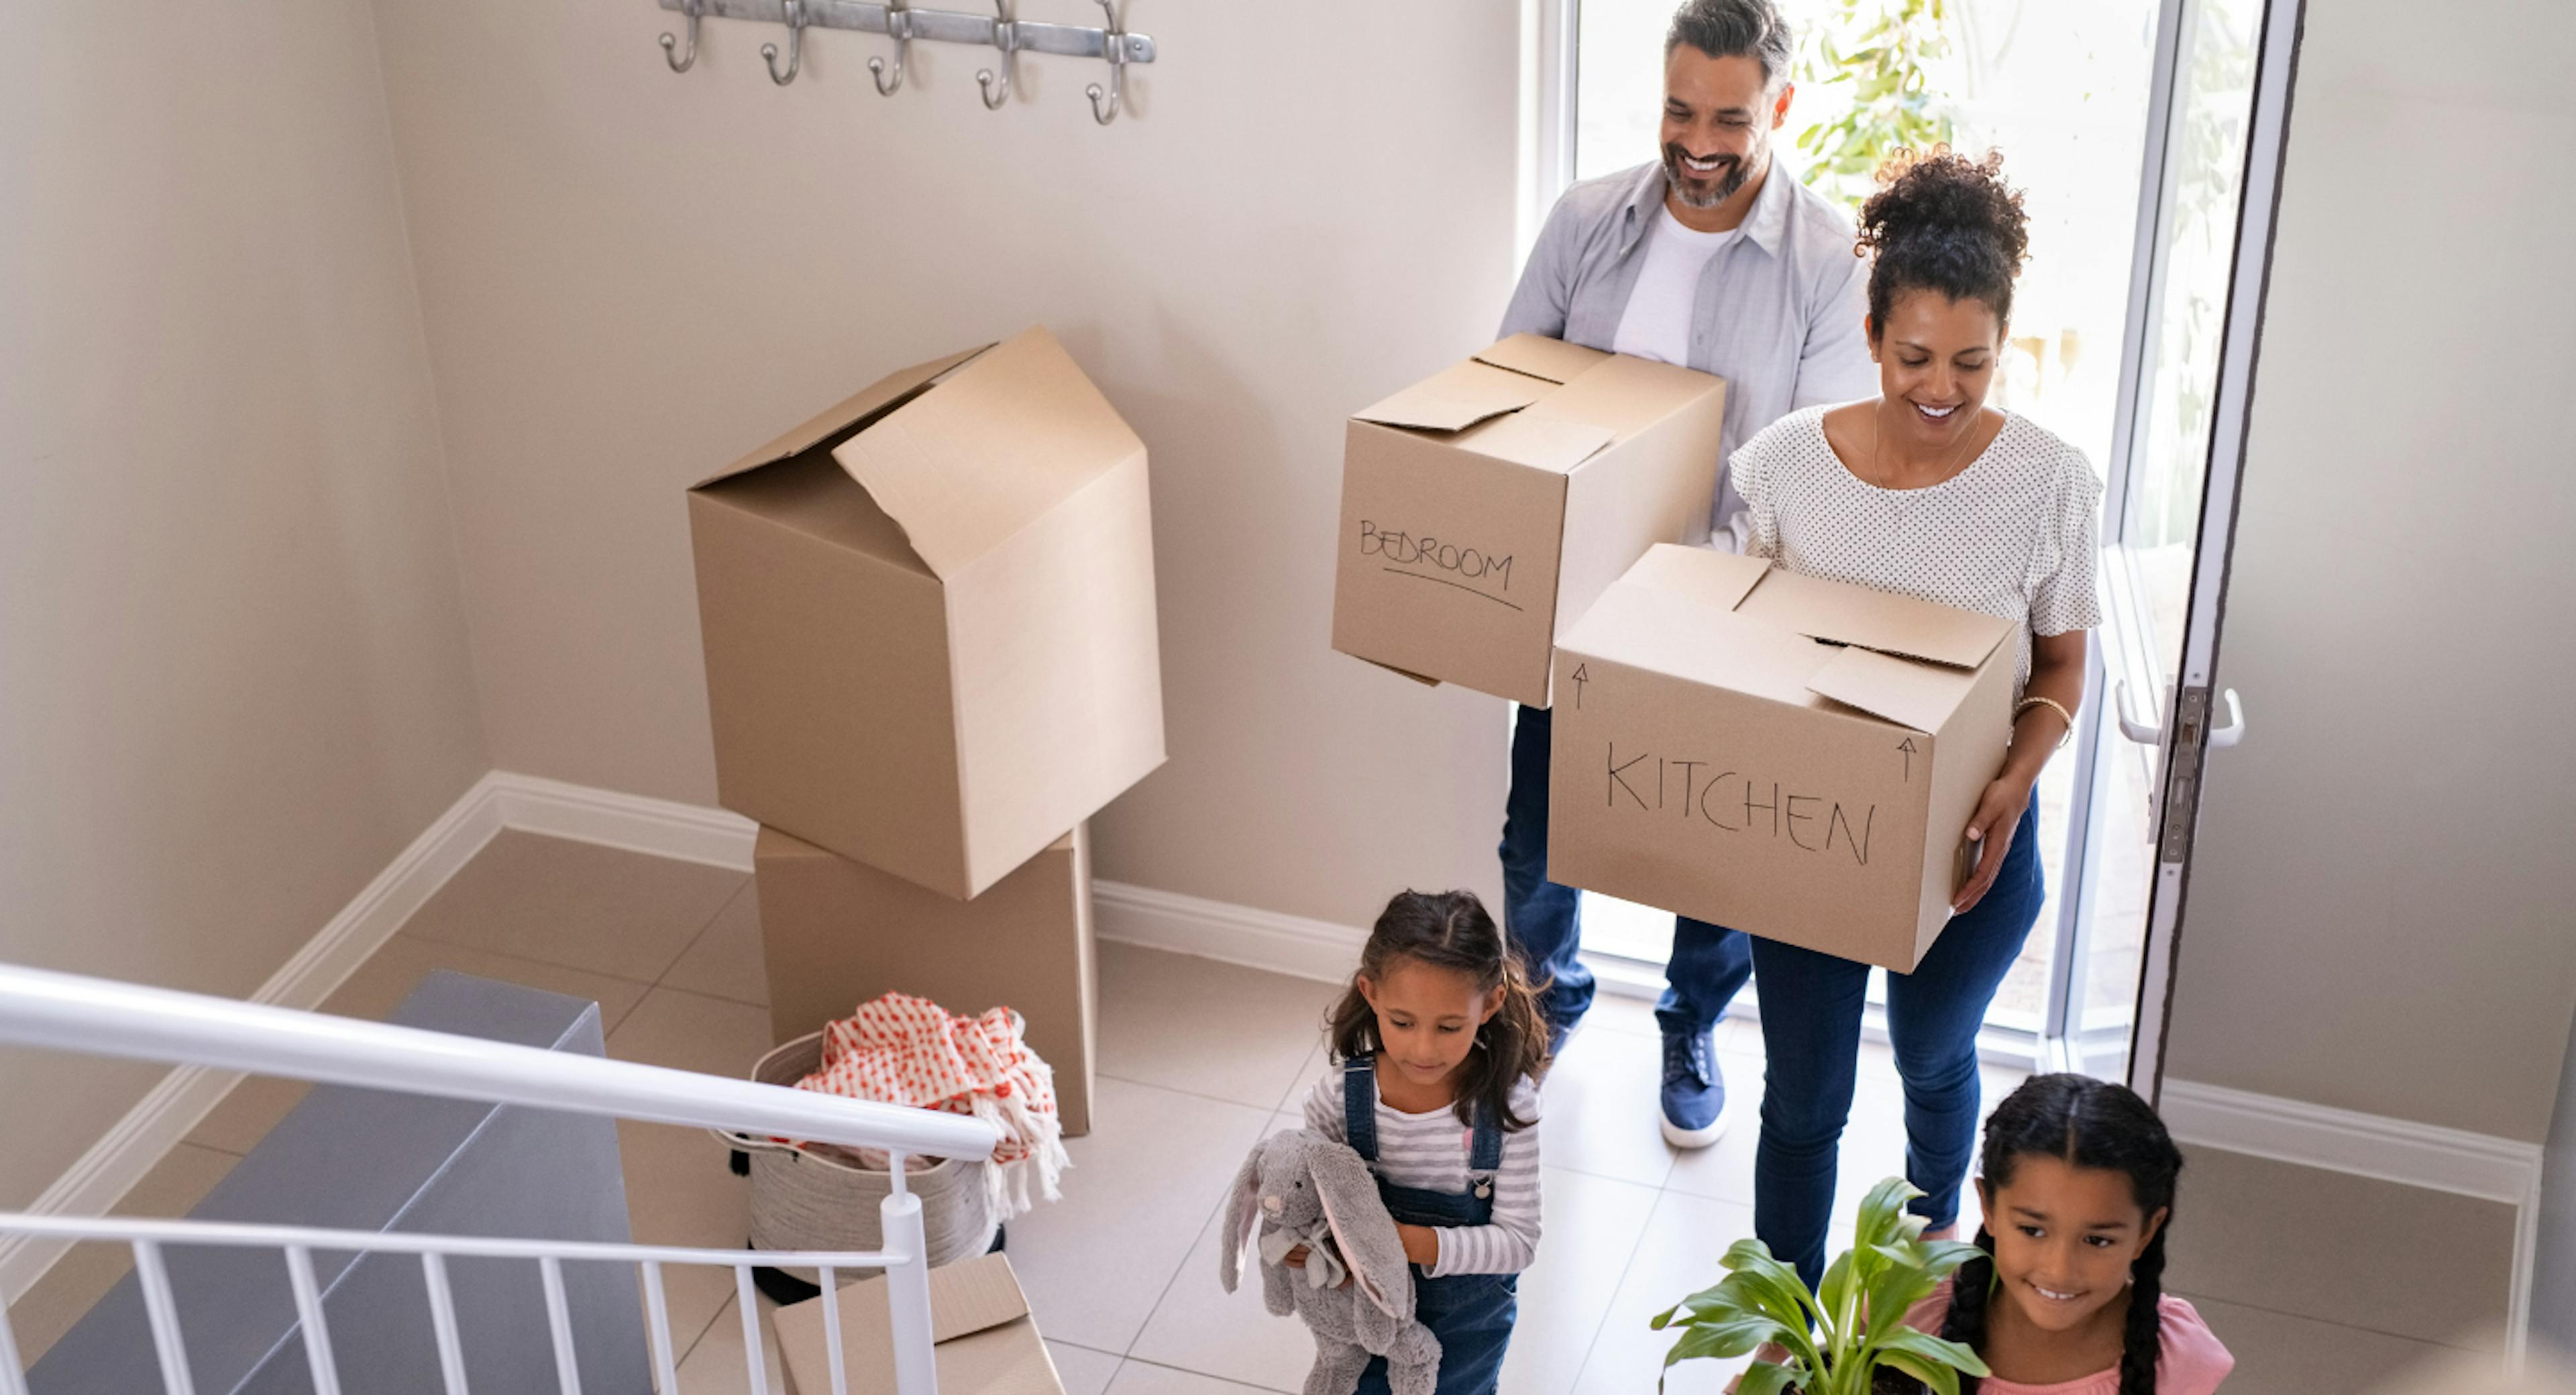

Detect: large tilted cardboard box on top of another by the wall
[688, 329, 1165, 898]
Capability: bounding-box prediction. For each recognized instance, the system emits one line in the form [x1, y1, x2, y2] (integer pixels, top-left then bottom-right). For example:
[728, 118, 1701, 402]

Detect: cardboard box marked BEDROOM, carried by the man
[1332, 335, 1726, 708]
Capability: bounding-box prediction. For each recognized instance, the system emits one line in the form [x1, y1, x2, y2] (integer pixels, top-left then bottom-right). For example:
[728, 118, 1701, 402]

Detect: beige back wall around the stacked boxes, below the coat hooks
[363, 0, 1520, 942]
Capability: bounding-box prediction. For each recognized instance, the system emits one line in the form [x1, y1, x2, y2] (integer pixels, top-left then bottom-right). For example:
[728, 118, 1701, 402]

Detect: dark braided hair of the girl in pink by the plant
[1940, 1076, 2182, 1395]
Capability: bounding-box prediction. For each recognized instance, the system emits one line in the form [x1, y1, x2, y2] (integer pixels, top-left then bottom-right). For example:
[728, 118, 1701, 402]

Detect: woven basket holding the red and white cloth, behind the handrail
[716, 1032, 1000, 1284]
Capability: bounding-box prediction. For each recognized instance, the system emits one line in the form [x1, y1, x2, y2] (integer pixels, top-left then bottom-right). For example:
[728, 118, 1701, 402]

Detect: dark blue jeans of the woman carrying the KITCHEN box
[1754, 801, 2045, 1287]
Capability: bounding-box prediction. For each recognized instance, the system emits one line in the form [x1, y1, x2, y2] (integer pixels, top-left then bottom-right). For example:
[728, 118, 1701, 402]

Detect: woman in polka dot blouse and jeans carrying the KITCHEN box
[1731, 150, 2102, 1284]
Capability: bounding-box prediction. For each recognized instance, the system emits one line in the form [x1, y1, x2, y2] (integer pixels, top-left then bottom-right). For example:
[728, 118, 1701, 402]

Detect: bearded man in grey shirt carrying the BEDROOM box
[1502, 0, 1878, 1148]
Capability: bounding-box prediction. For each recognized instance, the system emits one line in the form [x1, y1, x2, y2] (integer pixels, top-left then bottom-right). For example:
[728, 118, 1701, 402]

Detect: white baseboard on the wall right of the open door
[2159, 1081, 2545, 1361]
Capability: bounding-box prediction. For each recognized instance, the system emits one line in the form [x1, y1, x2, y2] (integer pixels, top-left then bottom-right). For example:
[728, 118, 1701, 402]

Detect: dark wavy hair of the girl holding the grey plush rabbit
[1324, 891, 1548, 1133]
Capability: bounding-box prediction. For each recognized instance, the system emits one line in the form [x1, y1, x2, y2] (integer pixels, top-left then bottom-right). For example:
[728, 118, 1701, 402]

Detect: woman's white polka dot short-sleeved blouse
[1729, 406, 2102, 695]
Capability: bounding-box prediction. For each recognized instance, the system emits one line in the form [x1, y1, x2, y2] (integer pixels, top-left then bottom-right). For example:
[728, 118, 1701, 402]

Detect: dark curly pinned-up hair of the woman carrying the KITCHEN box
[1858, 147, 2030, 325]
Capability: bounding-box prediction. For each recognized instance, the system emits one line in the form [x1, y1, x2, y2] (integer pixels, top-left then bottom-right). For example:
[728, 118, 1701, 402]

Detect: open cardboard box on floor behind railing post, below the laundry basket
[775, 1253, 1061, 1395]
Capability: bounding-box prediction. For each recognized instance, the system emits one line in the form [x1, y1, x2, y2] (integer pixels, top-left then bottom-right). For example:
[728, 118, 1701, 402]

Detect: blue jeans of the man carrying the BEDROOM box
[1502, 708, 1754, 1038]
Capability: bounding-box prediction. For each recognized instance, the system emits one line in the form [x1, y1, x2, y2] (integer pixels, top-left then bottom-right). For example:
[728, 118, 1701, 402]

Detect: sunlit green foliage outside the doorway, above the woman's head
[1793, 0, 1953, 209]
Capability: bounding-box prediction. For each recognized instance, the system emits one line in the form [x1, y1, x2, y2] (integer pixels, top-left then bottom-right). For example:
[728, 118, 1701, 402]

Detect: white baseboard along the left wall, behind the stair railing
[0, 775, 502, 1302]
